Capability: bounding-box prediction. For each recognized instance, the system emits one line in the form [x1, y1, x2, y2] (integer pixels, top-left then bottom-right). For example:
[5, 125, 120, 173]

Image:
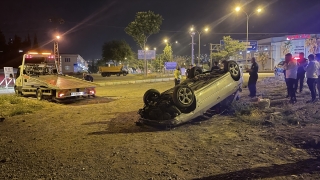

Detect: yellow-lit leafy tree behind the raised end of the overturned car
[211, 36, 246, 61]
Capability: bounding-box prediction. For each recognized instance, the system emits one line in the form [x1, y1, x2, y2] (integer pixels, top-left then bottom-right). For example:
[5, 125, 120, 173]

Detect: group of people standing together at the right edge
[283, 53, 320, 104]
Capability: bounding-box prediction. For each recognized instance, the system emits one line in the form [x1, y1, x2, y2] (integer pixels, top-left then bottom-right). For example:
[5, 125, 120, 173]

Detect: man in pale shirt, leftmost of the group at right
[283, 53, 298, 104]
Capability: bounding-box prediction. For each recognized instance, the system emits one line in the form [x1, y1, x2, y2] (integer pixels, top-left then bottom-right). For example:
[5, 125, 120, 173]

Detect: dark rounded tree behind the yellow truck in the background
[102, 40, 132, 64]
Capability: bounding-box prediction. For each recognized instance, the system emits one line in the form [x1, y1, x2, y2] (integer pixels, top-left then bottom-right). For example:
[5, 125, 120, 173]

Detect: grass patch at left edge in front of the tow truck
[0, 95, 57, 117]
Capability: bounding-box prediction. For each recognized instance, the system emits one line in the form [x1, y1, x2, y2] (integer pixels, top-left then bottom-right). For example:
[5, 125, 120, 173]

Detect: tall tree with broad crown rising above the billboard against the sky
[125, 11, 163, 74]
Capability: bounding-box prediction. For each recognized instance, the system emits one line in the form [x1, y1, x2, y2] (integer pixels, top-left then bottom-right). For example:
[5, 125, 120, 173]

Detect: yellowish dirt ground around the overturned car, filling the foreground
[0, 78, 320, 180]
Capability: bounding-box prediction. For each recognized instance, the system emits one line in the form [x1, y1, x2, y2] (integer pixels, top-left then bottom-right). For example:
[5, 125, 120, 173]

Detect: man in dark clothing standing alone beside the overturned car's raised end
[247, 57, 259, 97]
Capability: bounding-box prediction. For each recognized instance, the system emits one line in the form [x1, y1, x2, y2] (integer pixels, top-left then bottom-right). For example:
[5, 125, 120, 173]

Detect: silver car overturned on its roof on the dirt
[138, 61, 243, 126]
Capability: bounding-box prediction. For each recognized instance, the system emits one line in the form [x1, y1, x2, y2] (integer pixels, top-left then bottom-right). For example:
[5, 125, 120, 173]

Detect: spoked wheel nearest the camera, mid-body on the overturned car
[173, 85, 194, 108]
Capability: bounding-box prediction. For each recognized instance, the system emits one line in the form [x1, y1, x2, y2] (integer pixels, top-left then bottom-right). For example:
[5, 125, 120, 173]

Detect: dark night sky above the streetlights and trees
[0, 0, 320, 59]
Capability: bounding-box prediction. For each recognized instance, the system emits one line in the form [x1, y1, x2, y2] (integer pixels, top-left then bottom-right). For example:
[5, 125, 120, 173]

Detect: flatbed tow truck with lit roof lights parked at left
[14, 52, 96, 100]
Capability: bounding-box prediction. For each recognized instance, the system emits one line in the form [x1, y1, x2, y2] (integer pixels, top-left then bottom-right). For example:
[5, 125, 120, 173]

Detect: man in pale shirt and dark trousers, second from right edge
[304, 54, 320, 103]
